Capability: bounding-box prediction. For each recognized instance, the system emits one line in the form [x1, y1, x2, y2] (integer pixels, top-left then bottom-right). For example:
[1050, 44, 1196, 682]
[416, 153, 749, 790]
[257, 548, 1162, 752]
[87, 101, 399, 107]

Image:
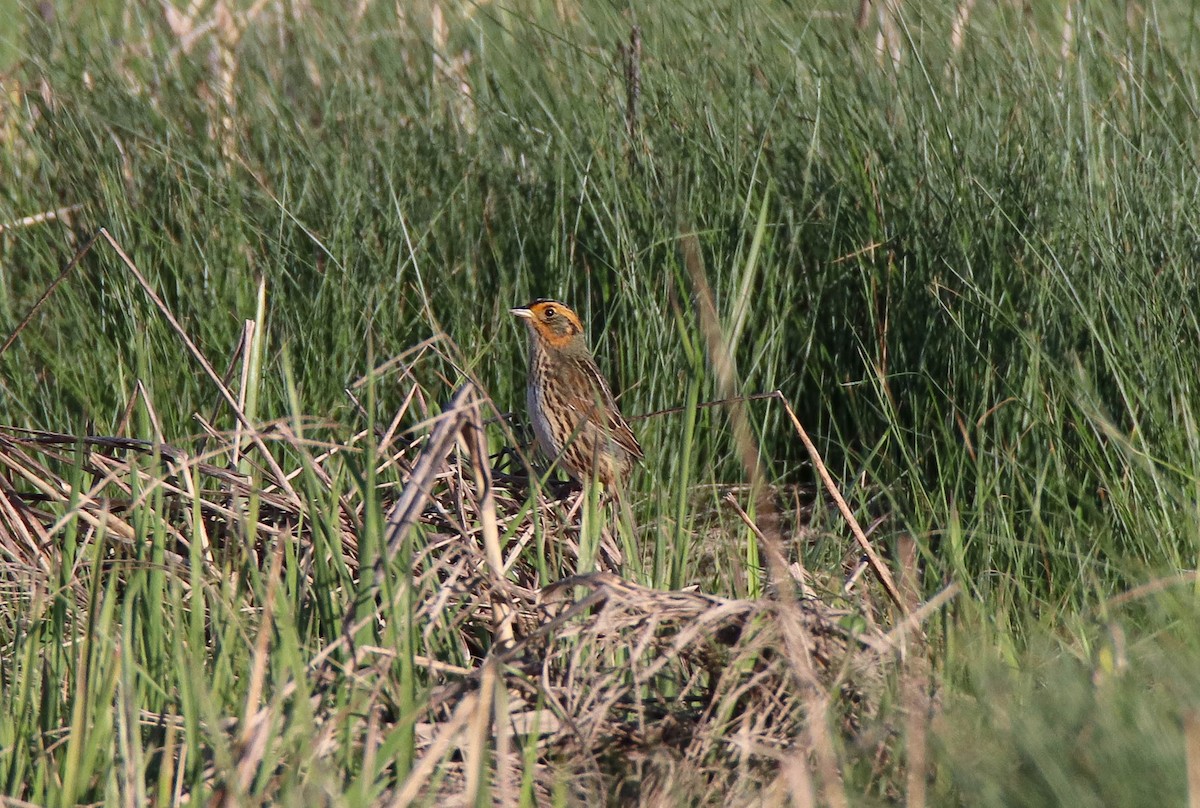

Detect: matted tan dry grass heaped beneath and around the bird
[0, 364, 950, 804]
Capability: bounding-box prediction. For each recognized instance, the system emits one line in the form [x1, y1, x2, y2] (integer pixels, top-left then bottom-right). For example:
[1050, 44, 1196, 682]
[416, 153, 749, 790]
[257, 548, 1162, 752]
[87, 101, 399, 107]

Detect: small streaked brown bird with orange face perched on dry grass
[509, 299, 643, 490]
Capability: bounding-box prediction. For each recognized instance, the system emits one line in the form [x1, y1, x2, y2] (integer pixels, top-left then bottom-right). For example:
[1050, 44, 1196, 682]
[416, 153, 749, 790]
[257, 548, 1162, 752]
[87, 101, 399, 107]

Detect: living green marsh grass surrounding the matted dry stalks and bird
[0, 0, 1200, 806]
